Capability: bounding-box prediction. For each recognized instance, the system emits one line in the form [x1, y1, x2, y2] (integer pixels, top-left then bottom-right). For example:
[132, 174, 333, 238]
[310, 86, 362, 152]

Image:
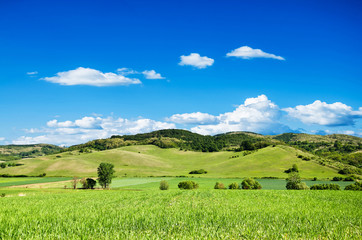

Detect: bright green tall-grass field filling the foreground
[0, 189, 362, 239]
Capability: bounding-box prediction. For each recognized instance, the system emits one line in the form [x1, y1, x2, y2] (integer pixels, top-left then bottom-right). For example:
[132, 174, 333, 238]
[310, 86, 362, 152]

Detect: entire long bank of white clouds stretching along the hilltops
[12, 94, 362, 146]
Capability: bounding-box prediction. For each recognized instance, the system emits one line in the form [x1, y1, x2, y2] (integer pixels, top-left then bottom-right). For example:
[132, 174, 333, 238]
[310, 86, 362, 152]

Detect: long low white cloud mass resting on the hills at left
[13, 117, 176, 146]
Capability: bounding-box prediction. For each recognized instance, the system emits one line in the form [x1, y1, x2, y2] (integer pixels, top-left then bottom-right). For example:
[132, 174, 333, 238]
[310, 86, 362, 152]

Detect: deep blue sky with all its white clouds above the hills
[0, 0, 362, 145]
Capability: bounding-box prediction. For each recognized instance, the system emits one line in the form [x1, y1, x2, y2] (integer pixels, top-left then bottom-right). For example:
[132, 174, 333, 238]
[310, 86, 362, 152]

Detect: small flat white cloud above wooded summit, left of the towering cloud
[166, 112, 217, 124]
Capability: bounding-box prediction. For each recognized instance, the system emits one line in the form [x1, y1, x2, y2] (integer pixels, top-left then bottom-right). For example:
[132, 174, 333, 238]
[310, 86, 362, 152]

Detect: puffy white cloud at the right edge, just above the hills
[284, 100, 362, 127]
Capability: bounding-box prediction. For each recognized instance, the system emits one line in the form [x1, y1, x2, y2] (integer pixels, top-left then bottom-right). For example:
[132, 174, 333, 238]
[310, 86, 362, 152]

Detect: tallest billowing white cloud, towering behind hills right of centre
[187, 95, 290, 135]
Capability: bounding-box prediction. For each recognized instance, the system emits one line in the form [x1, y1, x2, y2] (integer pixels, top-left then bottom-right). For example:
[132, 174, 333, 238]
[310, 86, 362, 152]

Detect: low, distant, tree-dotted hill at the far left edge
[0, 144, 63, 161]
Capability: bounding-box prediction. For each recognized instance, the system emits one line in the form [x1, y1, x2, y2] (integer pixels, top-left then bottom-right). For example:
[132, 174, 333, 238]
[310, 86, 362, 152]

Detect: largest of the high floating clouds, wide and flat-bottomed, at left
[42, 67, 141, 87]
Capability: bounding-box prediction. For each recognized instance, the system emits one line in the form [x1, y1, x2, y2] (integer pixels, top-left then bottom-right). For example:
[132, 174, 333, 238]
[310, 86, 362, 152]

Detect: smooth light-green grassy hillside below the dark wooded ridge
[0, 145, 338, 178]
